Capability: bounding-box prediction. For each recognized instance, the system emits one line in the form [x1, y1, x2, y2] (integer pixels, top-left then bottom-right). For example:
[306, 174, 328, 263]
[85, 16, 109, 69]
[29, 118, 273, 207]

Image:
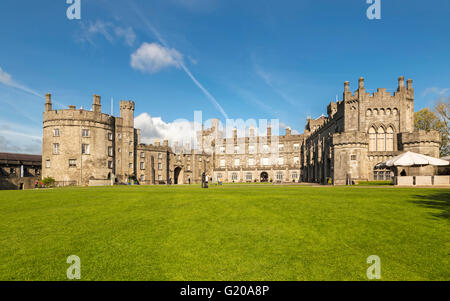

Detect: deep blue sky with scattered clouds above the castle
[0, 0, 450, 153]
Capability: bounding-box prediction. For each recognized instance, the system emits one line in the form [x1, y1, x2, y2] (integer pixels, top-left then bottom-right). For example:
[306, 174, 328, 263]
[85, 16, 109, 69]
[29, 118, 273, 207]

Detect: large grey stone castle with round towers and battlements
[42, 77, 440, 185]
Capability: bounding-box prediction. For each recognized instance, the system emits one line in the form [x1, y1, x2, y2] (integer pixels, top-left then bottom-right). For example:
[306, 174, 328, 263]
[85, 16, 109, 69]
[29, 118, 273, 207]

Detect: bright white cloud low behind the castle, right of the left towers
[134, 113, 197, 146]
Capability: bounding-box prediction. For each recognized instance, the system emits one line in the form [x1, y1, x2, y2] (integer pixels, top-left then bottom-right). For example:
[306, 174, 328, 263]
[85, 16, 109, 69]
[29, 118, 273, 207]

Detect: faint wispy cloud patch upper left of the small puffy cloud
[78, 20, 136, 46]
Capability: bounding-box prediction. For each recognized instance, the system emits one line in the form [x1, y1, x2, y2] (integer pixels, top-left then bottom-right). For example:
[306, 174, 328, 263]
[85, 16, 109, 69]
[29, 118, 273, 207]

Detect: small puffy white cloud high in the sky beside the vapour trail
[131, 43, 183, 73]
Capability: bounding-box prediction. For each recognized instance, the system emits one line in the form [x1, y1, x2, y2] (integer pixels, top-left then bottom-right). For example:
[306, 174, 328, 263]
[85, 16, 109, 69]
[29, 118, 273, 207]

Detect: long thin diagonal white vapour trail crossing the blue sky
[130, 1, 228, 119]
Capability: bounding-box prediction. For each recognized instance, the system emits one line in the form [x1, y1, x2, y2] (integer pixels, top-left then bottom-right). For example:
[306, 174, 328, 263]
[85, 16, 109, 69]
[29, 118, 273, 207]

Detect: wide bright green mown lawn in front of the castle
[0, 185, 450, 280]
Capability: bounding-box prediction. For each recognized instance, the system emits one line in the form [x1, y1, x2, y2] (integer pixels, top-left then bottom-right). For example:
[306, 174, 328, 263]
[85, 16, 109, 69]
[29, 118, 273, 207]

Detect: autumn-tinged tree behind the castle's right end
[414, 98, 450, 156]
